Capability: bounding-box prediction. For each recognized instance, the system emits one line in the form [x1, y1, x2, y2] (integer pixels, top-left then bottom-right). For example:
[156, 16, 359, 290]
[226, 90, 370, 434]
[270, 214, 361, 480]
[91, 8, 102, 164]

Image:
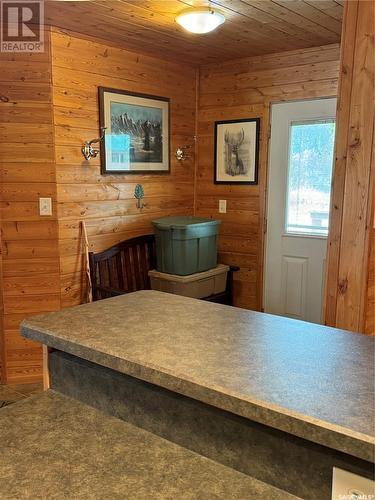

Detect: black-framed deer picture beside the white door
[214, 118, 260, 184]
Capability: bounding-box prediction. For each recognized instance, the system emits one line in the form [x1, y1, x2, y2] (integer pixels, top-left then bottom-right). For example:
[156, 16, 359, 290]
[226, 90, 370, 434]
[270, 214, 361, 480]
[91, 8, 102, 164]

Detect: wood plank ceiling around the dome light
[46, 0, 344, 64]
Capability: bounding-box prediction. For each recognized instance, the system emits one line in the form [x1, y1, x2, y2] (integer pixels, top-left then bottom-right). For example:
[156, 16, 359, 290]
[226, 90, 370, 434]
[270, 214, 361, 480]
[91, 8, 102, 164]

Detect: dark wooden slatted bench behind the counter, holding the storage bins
[89, 234, 239, 305]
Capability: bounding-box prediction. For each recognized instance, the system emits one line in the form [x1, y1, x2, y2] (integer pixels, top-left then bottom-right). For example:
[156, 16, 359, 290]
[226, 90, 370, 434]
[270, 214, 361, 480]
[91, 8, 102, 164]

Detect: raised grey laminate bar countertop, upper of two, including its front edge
[22, 291, 375, 460]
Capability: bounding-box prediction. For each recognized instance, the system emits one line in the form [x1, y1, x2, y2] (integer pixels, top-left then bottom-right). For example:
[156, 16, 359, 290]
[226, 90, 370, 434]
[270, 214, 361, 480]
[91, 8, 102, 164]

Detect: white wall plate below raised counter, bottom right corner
[332, 467, 375, 500]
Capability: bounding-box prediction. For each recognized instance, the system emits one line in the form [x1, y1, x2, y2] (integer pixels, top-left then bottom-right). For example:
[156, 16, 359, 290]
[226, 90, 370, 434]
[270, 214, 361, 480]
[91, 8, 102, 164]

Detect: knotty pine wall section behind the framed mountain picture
[52, 31, 196, 307]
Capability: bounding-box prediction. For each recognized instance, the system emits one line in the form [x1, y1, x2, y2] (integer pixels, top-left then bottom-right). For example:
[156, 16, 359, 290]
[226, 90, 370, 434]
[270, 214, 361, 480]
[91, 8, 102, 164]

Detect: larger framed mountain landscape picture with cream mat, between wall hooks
[98, 87, 170, 175]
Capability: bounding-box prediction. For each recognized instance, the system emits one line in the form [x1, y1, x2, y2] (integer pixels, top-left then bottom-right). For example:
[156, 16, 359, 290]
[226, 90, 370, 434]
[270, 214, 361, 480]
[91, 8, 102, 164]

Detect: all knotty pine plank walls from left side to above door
[0, 23, 374, 382]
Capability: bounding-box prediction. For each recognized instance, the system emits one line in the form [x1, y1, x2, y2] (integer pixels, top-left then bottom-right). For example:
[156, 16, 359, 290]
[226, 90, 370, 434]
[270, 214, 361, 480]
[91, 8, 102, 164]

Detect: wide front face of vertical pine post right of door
[336, 1, 375, 331]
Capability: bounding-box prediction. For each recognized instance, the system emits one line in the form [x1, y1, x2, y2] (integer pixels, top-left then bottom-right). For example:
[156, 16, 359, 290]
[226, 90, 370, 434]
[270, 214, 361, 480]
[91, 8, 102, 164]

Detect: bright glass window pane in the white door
[286, 120, 335, 236]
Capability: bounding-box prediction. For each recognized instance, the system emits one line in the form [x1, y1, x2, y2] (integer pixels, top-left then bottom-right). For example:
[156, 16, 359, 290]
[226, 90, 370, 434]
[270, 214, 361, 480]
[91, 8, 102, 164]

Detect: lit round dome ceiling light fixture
[176, 7, 225, 34]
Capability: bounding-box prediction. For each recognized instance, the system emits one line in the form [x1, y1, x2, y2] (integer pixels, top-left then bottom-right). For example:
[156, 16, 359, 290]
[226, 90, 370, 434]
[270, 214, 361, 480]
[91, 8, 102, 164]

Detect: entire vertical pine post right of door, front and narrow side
[325, 0, 375, 331]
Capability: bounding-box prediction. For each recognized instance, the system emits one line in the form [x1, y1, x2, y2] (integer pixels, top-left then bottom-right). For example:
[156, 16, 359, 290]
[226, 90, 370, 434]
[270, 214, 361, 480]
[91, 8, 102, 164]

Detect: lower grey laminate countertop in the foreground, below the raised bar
[0, 391, 297, 500]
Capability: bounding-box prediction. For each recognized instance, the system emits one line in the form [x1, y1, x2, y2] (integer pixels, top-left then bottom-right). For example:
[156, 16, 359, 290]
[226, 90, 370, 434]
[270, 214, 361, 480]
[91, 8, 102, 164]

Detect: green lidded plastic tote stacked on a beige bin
[152, 216, 220, 276]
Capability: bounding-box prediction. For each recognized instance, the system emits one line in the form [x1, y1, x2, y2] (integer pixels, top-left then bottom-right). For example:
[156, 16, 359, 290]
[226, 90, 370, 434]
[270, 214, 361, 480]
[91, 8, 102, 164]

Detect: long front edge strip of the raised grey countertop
[21, 320, 375, 462]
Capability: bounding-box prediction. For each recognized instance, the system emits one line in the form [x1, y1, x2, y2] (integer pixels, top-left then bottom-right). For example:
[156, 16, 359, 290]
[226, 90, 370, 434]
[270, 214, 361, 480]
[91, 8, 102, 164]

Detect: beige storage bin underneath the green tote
[148, 264, 229, 299]
